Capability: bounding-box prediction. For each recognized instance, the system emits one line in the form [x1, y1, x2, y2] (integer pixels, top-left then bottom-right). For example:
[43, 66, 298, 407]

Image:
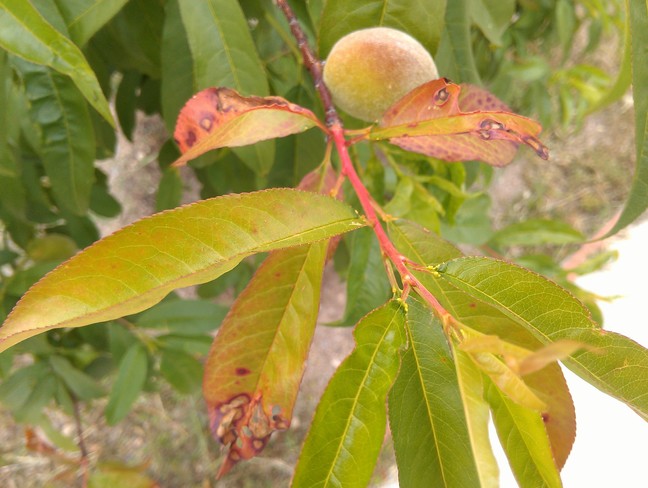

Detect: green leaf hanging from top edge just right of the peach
[434, 0, 481, 85]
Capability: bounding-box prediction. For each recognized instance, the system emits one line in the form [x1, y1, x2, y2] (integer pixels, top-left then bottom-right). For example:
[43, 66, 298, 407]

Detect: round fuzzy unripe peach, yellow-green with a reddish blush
[324, 27, 439, 122]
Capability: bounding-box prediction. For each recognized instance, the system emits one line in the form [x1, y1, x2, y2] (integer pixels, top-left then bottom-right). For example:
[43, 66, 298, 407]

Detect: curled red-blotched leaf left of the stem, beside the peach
[173, 87, 326, 166]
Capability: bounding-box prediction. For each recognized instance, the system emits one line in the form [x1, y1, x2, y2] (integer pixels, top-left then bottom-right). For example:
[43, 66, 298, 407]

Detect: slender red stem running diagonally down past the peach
[277, 0, 450, 323]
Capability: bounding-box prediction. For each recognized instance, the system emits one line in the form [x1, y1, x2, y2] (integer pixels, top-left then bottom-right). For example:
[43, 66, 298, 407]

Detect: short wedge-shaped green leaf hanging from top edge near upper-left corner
[55, 0, 128, 46]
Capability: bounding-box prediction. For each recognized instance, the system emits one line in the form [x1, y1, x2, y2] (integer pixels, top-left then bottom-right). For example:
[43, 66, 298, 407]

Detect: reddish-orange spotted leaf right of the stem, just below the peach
[369, 78, 549, 166]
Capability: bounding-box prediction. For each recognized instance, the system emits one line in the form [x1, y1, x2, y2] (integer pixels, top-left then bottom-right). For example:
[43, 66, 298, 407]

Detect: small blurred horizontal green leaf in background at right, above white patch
[489, 219, 585, 246]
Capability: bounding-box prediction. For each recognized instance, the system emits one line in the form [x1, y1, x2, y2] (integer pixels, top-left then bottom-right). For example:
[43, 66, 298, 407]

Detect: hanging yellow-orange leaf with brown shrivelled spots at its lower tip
[203, 241, 327, 477]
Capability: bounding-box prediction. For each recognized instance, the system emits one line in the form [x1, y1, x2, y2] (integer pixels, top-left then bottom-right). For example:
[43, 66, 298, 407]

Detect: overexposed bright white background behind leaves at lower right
[492, 222, 648, 488]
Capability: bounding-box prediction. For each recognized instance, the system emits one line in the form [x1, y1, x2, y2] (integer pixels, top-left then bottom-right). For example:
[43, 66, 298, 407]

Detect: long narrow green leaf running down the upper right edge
[606, 0, 648, 237]
